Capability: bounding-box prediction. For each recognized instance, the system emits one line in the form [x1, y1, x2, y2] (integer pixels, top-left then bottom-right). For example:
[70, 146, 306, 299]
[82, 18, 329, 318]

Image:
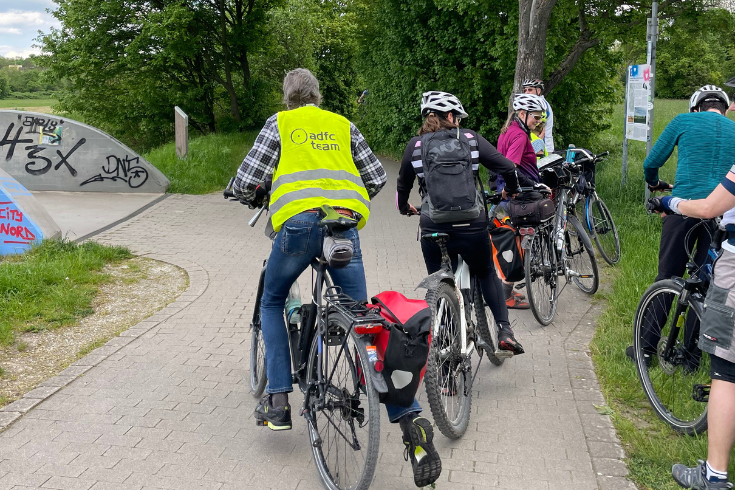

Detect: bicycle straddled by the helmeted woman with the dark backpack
[417, 227, 513, 439]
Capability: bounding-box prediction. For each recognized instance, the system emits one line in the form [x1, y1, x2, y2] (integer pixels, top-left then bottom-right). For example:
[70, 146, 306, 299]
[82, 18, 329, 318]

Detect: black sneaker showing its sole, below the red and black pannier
[399, 413, 442, 487]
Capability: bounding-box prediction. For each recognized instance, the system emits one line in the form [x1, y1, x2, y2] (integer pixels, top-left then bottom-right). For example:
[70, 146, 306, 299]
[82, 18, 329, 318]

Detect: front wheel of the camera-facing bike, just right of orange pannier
[523, 227, 559, 326]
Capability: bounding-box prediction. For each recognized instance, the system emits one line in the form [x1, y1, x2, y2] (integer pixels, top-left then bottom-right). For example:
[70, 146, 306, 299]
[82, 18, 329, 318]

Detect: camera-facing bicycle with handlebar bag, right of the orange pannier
[519, 155, 599, 325]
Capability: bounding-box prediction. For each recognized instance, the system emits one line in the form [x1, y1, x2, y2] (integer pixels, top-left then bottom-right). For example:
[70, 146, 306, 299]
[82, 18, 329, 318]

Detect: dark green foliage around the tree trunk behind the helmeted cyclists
[360, 0, 621, 152]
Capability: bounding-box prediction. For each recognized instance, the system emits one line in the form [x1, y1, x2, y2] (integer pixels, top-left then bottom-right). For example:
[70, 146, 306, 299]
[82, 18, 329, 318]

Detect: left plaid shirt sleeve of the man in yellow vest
[233, 114, 281, 202]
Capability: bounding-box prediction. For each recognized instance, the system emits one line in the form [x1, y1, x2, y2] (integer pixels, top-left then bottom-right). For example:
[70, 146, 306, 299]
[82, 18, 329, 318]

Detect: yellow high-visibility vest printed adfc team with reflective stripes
[269, 106, 370, 231]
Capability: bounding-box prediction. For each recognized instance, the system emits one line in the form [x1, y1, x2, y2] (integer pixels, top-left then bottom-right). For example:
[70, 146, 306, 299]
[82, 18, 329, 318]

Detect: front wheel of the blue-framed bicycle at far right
[633, 279, 711, 435]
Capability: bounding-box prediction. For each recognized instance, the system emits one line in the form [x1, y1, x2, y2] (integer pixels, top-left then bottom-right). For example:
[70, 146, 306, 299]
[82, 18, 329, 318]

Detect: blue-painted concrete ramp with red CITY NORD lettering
[0, 169, 61, 256]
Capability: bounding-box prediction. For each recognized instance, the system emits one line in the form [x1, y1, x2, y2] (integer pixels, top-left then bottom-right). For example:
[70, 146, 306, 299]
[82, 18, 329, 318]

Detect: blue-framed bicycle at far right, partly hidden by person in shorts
[633, 218, 722, 435]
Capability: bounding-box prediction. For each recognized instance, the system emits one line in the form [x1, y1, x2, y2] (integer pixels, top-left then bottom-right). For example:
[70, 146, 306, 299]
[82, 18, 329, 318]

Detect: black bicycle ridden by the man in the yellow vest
[224, 181, 387, 490]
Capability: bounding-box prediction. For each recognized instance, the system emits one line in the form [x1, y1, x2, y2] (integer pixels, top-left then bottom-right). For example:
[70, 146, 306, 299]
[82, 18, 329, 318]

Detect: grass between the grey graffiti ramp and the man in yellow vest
[144, 132, 258, 194]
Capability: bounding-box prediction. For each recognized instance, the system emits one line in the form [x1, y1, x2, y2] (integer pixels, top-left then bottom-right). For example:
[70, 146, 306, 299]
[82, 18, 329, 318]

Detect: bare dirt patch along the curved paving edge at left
[0, 257, 189, 407]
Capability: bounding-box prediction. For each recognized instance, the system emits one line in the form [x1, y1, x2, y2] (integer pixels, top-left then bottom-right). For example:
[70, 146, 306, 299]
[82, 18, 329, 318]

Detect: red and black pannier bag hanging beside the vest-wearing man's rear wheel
[372, 291, 431, 407]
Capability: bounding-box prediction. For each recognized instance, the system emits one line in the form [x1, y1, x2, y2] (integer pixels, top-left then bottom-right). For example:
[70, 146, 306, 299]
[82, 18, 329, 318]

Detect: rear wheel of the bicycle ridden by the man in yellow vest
[305, 313, 380, 490]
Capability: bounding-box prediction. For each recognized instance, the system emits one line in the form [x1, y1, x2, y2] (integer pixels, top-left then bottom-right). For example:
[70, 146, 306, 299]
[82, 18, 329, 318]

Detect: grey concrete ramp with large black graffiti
[0, 110, 170, 194]
